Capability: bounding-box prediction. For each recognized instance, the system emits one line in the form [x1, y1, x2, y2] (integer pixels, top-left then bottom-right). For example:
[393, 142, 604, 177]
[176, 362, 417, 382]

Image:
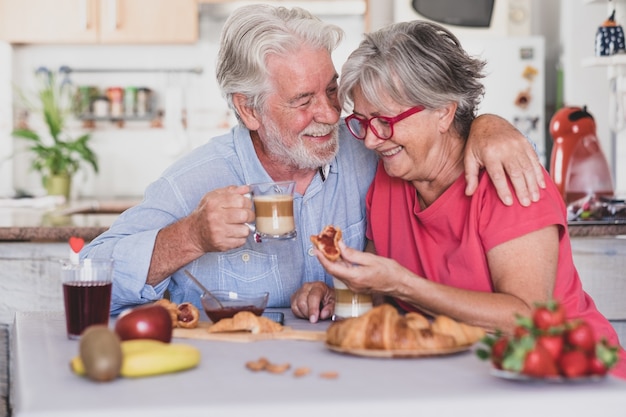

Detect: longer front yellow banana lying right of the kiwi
[120, 344, 200, 378]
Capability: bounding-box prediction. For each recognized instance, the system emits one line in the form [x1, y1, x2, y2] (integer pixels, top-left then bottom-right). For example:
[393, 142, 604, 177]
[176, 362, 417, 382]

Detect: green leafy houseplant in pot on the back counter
[12, 68, 98, 199]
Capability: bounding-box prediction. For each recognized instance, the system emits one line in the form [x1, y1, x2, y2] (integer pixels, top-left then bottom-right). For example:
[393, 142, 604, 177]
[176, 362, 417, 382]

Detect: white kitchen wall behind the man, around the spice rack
[6, 5, 365, 197]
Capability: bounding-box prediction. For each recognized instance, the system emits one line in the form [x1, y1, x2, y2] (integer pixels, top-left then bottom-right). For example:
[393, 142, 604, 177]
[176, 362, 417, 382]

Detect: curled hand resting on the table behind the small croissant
[291, 281, 335, 323]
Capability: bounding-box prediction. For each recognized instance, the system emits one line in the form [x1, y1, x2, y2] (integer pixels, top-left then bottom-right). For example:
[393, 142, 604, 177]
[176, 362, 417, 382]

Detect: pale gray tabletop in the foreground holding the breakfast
[11, 311, 626, 417]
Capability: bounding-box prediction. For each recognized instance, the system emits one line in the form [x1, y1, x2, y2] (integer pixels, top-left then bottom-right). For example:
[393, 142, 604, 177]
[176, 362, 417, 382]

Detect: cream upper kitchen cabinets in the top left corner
[0, 0, 198, 44]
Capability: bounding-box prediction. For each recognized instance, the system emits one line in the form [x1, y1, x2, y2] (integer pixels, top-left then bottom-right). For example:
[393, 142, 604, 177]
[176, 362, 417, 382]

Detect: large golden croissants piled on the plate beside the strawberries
[326, 304, 484, 350]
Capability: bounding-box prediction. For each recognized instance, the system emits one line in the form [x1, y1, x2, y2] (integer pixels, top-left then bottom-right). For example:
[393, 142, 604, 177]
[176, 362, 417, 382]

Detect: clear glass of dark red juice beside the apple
[61, 259, 113, 339]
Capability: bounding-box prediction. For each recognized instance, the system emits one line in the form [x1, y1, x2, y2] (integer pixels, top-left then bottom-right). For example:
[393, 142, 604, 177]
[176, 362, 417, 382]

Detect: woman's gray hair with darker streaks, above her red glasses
[339, 21, 485, 139]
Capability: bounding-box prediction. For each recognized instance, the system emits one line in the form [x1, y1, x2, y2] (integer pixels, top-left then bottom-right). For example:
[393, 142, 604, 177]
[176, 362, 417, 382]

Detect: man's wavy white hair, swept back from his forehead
[216, 4, 344, 122]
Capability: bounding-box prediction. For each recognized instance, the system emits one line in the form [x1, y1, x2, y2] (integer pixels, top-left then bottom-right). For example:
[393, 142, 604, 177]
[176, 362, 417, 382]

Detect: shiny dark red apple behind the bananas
[115, 304, 172, 343]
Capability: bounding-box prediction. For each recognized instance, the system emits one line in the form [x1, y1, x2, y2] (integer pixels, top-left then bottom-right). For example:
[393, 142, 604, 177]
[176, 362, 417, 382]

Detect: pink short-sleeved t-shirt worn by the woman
[367, 163, 626, 378]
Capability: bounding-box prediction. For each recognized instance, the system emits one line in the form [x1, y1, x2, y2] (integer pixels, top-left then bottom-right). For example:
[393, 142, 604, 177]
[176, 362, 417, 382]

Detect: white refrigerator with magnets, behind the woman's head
[460, 36, 550, 167]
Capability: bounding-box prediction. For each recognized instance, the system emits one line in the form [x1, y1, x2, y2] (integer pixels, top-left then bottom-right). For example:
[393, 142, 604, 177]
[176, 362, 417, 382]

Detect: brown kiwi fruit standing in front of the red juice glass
[80, 325, 122, 382]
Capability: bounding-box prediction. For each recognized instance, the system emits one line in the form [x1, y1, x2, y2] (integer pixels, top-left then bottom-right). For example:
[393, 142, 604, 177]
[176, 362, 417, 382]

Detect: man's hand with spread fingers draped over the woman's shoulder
[465, 114, 546, 206]
